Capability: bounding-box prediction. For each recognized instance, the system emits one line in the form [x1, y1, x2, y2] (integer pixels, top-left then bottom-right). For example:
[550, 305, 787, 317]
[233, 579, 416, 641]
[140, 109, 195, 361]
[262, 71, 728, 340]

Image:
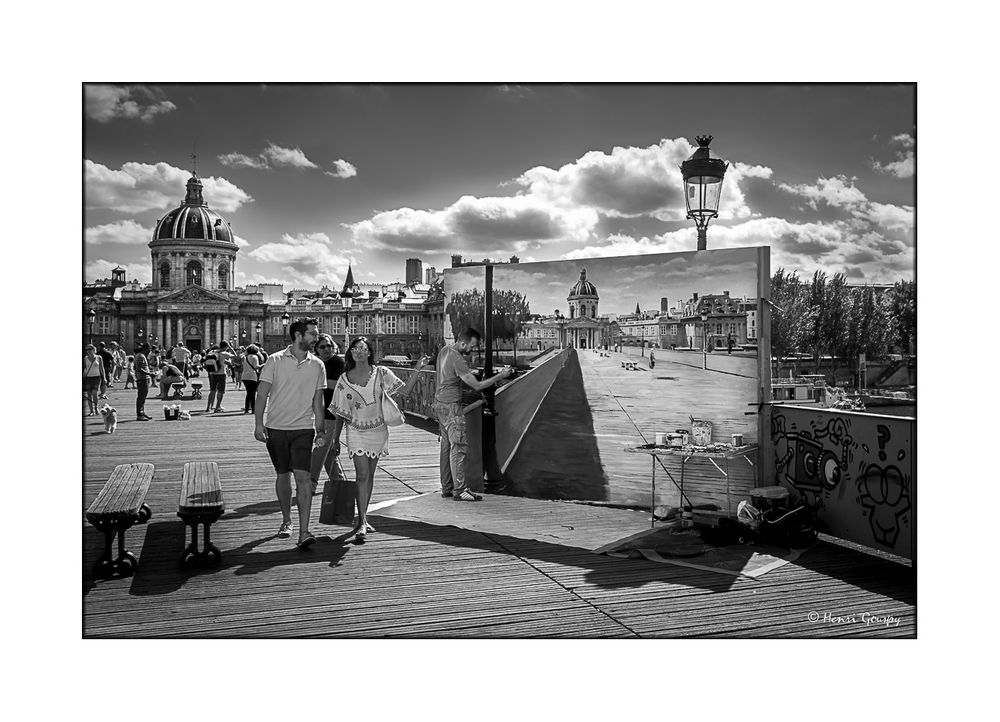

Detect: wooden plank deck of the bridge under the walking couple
[80, 376, 916, 638]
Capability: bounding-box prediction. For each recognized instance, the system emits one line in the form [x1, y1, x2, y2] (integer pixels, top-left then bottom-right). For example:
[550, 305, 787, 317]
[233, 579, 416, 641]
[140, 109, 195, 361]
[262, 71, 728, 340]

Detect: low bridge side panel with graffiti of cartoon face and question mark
[770, 406, 916, 559]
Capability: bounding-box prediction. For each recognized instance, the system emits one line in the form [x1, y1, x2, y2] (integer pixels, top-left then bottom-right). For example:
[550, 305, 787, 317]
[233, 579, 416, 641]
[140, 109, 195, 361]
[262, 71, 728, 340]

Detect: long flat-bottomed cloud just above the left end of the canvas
[346, 195, 598, 253]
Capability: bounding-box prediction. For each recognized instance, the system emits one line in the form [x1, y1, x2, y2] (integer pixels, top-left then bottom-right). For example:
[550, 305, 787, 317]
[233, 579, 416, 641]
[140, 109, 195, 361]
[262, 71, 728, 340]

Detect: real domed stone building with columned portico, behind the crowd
[84, 175, 268, 350]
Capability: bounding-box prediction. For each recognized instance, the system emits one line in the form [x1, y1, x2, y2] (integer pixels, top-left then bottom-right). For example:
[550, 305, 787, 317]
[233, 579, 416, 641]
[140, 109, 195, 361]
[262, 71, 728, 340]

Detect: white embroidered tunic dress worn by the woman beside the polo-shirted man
[329, 366, 404, 459]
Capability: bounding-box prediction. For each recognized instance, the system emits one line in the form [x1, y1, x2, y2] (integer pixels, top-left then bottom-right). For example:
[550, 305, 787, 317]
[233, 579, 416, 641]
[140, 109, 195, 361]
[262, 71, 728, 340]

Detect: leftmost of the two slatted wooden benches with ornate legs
[86, 464, 153, 579]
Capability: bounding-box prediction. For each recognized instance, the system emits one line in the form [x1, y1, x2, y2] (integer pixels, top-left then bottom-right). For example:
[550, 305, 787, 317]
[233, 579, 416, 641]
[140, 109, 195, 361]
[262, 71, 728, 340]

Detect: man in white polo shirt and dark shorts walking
[253, 318, 326, 549]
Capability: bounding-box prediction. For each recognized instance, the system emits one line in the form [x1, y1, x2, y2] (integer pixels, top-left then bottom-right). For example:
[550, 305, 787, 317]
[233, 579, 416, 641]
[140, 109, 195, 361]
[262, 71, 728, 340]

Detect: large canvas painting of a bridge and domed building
[444, 248, 768, 511]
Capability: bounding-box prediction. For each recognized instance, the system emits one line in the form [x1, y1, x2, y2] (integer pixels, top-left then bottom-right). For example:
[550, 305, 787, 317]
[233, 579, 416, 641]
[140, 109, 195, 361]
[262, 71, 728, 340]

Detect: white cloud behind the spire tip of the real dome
[84, 160, 253, 213]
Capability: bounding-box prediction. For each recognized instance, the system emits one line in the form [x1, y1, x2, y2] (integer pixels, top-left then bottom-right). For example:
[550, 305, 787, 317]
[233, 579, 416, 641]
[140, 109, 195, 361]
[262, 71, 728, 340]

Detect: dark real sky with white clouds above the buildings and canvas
[82, 83, 916, 290]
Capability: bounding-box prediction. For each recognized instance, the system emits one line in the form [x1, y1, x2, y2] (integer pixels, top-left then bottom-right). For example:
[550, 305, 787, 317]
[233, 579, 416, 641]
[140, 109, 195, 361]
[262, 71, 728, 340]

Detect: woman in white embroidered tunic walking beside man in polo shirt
[330, 336, 427, 544]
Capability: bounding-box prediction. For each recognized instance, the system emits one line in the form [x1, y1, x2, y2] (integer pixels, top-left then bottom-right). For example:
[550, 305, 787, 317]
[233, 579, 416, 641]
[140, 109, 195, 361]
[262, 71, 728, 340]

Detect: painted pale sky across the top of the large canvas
[445, 249, 757, 316]
